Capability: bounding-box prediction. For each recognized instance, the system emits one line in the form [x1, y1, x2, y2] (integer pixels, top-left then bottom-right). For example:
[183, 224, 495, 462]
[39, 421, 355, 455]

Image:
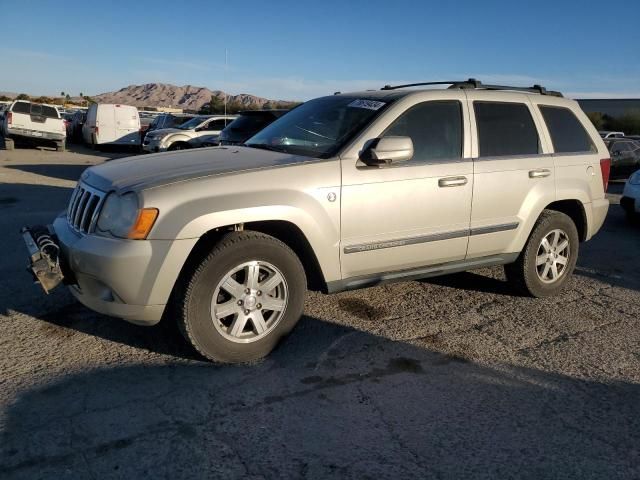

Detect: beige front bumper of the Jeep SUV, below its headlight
[25, 214, 197, 325]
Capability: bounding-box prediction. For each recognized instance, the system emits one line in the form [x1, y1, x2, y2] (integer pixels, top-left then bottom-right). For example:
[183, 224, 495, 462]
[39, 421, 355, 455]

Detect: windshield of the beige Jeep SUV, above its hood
[245, 95, 391, 158]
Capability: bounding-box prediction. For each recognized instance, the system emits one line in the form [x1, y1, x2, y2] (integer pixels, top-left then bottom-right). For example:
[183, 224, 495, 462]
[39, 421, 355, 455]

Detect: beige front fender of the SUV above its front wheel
[143, 162, 340, 281]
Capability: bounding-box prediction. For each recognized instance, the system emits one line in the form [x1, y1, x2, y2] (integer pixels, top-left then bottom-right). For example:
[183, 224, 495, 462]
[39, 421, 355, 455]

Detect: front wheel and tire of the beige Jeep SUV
[175, 231, 307, 363]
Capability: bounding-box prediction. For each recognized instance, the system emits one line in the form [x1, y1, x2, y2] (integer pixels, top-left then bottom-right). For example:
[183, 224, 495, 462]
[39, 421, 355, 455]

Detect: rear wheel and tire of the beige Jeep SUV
[504, 210, 580, 298]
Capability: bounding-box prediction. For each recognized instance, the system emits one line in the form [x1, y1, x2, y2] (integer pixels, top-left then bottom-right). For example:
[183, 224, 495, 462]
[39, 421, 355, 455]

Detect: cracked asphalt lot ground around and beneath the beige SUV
[0, 144, 640, 479]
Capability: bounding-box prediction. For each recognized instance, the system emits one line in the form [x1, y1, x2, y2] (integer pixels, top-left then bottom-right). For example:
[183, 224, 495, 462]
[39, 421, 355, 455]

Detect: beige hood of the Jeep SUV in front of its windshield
[80, 147, 318, 192]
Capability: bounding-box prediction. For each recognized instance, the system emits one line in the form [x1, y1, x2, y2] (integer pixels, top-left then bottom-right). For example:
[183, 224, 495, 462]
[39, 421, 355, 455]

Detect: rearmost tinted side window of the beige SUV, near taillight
[540, 105, 596, 153]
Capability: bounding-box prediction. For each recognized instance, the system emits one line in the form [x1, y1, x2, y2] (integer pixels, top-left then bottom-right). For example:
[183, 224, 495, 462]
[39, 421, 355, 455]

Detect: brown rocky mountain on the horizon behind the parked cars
[92, 83, 291, 110]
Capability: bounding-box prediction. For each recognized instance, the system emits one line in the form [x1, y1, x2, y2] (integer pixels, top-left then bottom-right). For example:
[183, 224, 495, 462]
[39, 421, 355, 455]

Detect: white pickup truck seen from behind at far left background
[0, 100, 67, 151]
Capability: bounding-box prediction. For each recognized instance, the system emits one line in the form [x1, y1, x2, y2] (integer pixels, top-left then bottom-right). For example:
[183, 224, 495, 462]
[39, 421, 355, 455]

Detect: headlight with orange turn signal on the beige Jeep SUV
[96, 193, 158, 240]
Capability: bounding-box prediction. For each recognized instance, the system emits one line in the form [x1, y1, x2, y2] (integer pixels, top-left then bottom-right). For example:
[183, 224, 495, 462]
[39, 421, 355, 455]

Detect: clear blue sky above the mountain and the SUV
[0, 0, 640, 100]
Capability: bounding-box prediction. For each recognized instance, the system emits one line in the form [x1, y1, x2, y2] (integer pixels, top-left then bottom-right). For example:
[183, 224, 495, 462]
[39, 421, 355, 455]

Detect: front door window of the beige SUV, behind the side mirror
[382, 101, 462, 163]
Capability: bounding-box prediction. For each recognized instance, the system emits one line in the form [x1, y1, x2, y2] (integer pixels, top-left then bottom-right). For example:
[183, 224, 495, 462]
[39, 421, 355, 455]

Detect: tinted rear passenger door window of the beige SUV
[473, 102, 540, 157]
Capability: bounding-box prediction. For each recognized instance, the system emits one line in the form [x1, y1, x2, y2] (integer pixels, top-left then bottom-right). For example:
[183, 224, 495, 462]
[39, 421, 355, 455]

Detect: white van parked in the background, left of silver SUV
[82, 103, 140, 146]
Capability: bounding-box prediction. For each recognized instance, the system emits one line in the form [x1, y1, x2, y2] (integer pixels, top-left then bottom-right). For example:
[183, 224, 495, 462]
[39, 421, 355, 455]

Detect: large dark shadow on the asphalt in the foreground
[1, 317, 640, 479]
